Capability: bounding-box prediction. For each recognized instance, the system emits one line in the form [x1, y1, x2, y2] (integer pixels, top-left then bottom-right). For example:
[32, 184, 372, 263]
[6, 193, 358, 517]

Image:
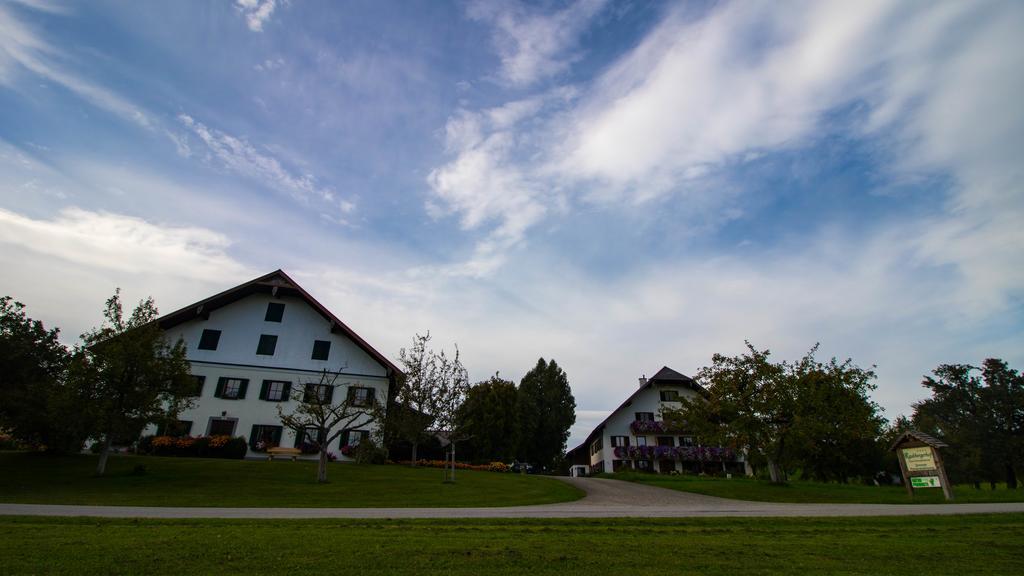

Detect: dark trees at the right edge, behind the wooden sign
[913, 359, 1024, 488]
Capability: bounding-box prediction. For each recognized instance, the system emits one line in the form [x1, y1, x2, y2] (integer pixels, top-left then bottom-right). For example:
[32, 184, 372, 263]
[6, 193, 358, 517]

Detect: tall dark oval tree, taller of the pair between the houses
[516, 358, 575, 469]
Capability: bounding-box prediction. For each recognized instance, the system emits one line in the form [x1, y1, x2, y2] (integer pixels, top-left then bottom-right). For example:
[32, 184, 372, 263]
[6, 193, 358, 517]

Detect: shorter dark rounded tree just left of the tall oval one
[458, 374, 518, 461]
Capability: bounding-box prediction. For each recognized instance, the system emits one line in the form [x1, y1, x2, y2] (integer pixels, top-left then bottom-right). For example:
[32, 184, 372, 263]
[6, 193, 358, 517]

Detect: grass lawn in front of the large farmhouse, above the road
[0, 452, 583, 504]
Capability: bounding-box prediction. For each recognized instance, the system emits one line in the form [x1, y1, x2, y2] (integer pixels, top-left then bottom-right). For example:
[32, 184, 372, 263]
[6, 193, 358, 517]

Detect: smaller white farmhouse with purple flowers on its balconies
[568, 366, 743, 476]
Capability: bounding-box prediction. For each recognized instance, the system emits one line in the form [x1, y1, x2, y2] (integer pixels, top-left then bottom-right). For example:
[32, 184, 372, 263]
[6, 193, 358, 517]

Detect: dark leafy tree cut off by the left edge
[0, 296, 88, 453]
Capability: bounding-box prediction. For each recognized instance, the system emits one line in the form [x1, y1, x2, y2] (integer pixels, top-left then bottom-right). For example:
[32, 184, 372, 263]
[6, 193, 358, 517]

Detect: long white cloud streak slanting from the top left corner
[0, 2, 153, 128]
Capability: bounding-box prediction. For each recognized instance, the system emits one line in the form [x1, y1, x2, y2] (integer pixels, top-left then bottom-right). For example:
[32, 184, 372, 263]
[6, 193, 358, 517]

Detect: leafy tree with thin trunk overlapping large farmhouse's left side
[69, 289, 195, 476]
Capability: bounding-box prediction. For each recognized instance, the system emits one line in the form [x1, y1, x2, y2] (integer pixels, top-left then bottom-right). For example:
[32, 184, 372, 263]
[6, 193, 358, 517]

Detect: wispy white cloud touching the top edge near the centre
[468, 0, 607, 86]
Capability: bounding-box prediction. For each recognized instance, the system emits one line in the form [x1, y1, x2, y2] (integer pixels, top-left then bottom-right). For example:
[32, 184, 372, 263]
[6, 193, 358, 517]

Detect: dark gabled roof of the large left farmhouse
[157, 270, 402, 376]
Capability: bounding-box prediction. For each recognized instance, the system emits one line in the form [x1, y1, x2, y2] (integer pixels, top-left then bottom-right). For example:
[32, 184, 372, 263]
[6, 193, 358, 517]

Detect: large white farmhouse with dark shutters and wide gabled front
[148, 270, 401, 459]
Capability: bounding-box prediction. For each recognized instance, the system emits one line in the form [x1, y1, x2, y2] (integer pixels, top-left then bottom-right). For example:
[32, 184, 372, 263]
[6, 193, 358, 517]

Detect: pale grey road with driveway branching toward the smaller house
[0, 478, 1024, 519]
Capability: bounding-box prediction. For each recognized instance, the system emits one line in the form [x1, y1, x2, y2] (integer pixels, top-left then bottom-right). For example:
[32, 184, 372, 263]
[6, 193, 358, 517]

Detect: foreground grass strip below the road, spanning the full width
[0, 515, 1024, 576]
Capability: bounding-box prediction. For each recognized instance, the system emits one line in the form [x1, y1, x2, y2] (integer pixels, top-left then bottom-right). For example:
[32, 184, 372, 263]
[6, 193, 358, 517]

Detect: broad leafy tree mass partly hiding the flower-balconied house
[662, 342, 885, 483]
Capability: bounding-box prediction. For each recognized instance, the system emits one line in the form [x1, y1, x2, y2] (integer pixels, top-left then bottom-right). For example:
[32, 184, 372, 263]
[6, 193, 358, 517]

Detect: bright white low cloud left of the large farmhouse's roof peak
[0, 208, 256, 342]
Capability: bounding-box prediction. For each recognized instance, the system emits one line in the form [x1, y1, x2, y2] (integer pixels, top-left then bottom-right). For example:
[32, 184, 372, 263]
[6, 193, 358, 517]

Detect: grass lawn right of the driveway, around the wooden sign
[602, 472, 1024, 504]
